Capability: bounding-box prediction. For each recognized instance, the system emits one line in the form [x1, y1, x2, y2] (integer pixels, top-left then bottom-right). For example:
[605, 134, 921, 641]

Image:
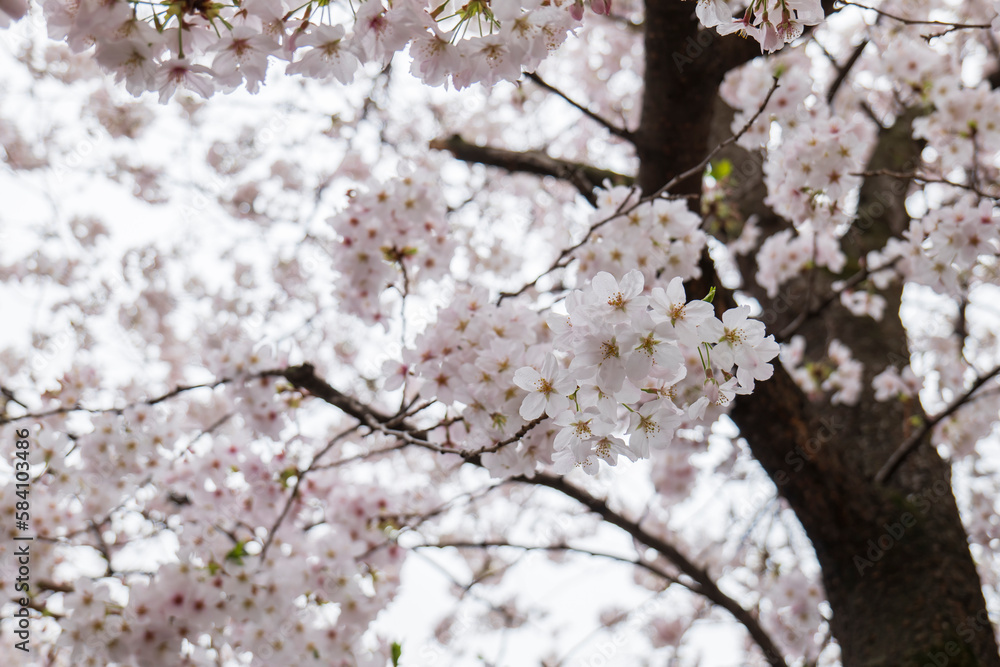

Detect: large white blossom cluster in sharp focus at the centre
[393, 270, 778, 476]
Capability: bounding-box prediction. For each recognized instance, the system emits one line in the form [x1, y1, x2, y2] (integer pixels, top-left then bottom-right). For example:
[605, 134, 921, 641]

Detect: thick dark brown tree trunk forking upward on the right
[636, 0, 1000, 667]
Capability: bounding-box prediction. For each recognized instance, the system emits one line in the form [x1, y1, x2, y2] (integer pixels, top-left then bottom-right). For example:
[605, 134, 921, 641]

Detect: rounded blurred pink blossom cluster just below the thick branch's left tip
[327, 174, 456, 324]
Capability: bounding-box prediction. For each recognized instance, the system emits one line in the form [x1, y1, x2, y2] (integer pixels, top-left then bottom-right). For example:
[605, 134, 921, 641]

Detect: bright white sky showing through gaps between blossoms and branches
[0, 2, 1000, 667]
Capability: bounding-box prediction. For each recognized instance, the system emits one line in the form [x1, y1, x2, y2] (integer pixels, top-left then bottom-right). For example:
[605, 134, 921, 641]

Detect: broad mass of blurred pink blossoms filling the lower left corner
[8, 392, 414, 666]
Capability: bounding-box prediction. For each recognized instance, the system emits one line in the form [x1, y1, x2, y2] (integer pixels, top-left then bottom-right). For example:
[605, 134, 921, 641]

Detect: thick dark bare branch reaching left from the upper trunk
[429, 134, 633, 206]
